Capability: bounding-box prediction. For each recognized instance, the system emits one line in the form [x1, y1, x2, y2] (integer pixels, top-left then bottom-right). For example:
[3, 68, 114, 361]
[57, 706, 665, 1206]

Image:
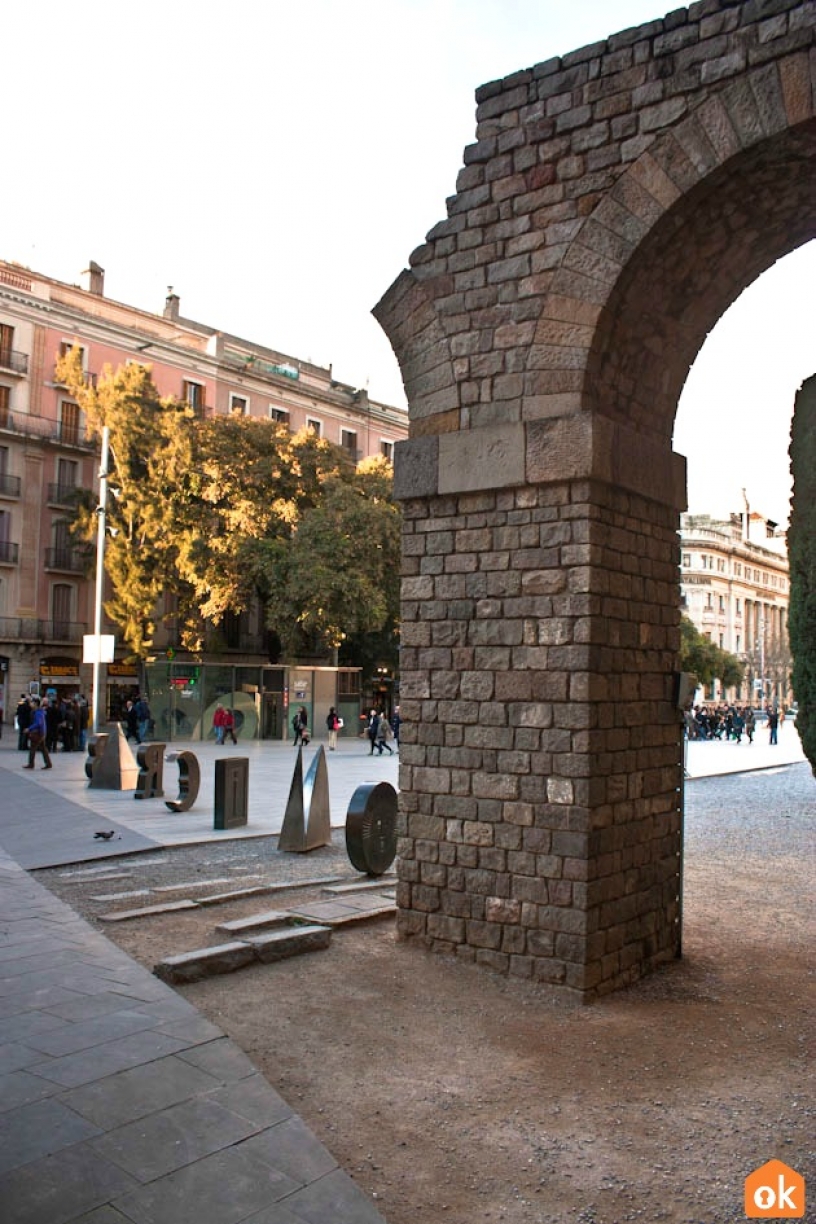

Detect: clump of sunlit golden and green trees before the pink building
[59, 353, 400, 659]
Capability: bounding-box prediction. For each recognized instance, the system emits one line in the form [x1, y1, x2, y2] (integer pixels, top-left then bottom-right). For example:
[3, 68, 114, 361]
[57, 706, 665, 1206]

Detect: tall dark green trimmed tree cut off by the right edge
[788, 376, 816, 775]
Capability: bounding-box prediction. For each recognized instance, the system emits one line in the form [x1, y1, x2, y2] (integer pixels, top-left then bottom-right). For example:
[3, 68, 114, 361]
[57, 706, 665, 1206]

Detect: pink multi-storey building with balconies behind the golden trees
[0, 261, 407, 736]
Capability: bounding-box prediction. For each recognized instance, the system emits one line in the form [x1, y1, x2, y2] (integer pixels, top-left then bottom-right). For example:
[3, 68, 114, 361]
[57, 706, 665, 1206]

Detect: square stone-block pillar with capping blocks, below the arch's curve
[396, 415, 685, 998]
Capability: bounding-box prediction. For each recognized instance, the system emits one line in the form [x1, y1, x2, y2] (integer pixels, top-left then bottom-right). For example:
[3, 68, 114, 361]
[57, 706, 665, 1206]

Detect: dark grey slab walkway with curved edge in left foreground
[0, 852, 384, 1224]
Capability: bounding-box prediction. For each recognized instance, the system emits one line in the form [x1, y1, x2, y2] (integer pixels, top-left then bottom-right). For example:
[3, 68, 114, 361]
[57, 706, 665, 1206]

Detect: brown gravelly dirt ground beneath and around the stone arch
[38, 773, 816, 1224]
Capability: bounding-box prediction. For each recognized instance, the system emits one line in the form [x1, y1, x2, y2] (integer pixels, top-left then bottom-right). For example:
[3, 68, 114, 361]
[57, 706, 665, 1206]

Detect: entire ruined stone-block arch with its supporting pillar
[374, 0, 816, 998]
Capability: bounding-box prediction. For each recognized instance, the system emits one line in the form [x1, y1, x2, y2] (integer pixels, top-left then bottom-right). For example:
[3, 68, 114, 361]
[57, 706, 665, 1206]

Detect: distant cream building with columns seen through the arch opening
[680, 507, 790, 705]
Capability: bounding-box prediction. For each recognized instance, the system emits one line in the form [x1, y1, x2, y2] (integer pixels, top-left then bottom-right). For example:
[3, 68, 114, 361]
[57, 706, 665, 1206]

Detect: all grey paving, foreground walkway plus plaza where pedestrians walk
[0, 723, 804, 1224]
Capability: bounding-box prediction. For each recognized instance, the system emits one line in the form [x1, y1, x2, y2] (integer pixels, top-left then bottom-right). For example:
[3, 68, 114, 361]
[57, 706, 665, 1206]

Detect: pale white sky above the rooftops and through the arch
[0, 0, 816, 521]
